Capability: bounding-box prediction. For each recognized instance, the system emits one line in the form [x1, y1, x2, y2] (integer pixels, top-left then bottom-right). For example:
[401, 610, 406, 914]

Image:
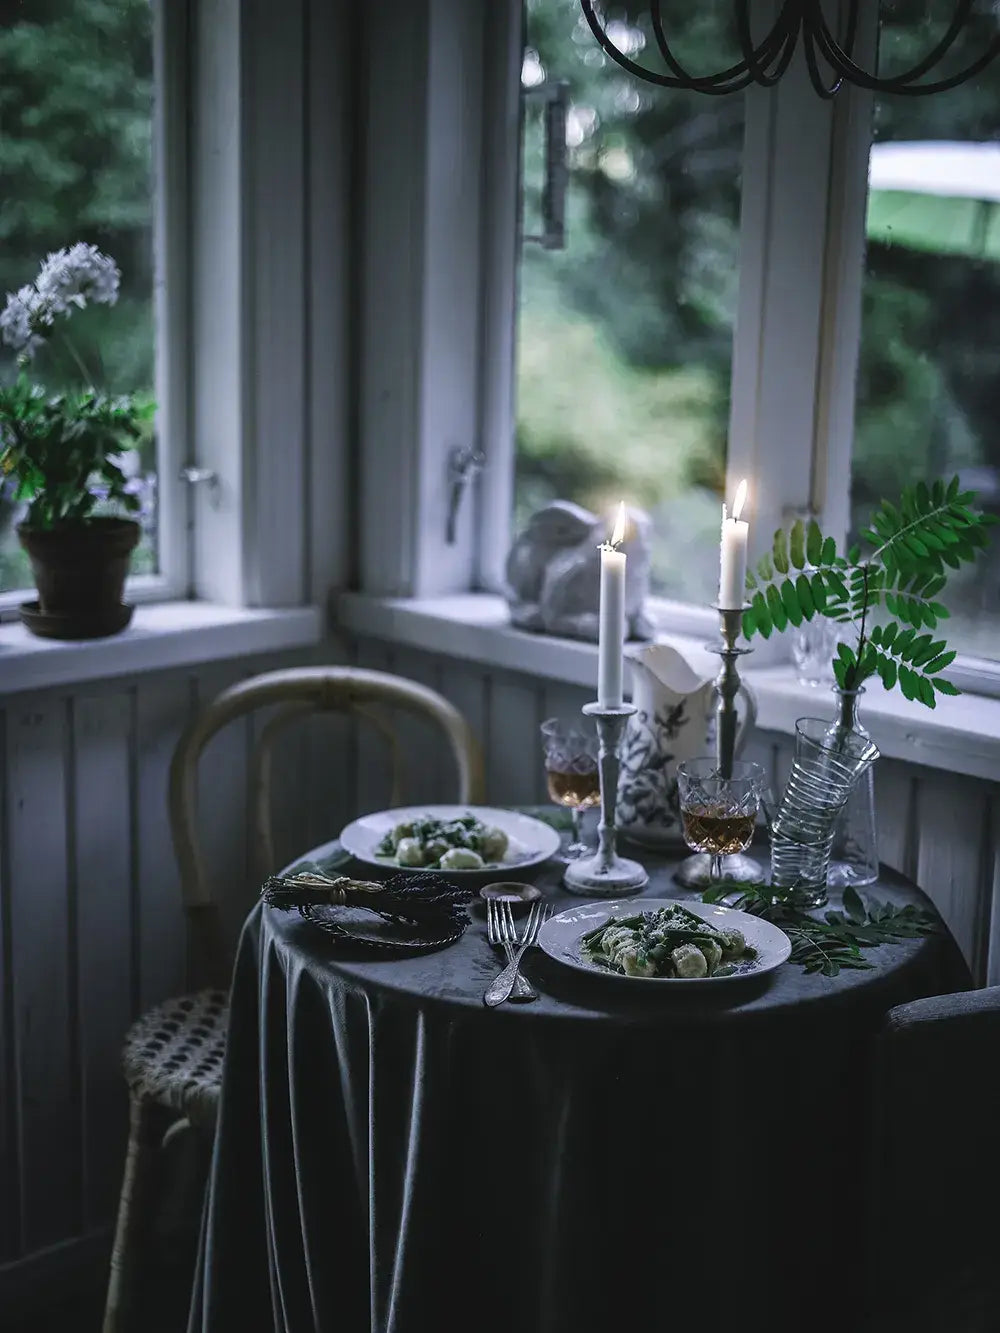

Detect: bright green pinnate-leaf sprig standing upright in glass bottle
[743, 477, 997, 708]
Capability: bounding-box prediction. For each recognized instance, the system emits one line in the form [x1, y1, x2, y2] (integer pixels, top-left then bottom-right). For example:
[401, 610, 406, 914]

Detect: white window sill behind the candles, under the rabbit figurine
[336, 593, 1000, 781]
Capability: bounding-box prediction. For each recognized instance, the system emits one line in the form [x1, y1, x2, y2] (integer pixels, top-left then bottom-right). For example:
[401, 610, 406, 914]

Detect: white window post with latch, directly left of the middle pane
[360, 0, 487, 596]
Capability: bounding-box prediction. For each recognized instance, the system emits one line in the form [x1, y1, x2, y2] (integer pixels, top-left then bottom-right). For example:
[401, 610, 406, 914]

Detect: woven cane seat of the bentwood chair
[121, 990, 229, 1128]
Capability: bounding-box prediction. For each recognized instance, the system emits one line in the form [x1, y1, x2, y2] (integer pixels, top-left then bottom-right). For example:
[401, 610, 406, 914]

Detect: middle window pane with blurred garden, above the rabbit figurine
[515, 0, 743, 601]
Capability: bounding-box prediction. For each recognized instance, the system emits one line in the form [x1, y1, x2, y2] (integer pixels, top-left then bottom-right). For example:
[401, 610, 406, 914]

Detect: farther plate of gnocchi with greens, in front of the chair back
[340, 805, 559, 880]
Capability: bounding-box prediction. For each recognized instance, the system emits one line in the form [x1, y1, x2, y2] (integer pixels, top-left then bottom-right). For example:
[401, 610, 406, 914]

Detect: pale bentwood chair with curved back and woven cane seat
[104, 667, 483, 1333]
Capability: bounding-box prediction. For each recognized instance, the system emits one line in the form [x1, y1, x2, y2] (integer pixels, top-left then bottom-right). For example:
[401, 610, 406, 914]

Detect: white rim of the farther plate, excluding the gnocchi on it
[340, 805, 559, 880]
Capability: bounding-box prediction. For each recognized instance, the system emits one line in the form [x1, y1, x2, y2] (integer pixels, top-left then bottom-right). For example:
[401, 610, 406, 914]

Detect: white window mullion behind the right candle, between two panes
[728, 1, 875, 573]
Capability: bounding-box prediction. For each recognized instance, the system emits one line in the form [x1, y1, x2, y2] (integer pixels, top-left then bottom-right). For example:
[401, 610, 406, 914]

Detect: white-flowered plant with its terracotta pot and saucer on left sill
[0, 243, 153, 639]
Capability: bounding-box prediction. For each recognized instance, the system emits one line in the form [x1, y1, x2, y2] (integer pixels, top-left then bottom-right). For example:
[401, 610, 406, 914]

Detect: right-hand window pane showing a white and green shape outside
[851, 10, 1000, 657]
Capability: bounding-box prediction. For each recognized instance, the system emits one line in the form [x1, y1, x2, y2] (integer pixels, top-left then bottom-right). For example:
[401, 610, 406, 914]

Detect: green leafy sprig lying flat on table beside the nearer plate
[701, 880, 940, 977]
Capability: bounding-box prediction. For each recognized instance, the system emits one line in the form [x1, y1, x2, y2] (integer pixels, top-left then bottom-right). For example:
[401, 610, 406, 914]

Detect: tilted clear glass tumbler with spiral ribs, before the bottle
[771, 717, 879, 908]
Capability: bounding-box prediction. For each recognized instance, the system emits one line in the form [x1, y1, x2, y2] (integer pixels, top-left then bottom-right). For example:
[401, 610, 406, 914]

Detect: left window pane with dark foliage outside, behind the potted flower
[0, 0, 156, 591]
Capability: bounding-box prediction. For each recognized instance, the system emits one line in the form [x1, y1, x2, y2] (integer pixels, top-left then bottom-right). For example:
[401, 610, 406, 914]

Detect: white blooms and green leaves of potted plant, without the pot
[0, 244, 153, 528]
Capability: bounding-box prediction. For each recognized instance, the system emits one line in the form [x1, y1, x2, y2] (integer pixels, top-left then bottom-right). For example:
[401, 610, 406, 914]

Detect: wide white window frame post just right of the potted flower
[0, 0, 355, 623]
